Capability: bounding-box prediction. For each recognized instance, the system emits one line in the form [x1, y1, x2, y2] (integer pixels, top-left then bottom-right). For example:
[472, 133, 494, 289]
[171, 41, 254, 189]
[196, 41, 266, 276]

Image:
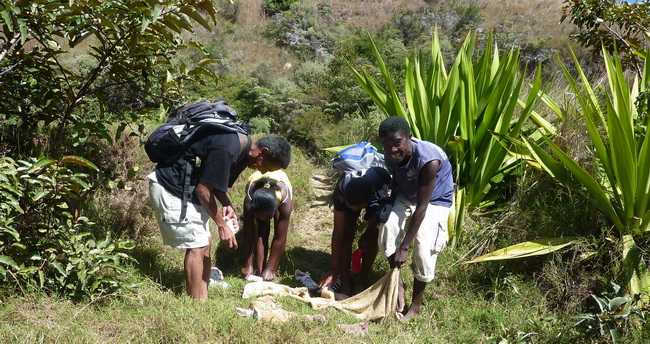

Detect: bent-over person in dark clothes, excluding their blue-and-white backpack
[320, 167, 390, 295]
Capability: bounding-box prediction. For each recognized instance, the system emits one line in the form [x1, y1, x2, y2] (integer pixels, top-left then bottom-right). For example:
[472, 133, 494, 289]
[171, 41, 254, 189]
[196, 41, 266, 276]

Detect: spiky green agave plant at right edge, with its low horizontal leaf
[472, 49, 650, 294]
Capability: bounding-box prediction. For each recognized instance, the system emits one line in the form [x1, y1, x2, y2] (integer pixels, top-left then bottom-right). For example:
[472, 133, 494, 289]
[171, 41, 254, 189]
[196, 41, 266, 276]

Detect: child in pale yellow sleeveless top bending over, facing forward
[242, 165, 293, 281]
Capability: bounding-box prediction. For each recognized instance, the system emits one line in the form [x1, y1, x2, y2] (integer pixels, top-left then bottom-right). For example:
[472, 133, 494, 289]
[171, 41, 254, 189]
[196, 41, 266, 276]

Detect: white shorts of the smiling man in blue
[379, 197, 449, 282]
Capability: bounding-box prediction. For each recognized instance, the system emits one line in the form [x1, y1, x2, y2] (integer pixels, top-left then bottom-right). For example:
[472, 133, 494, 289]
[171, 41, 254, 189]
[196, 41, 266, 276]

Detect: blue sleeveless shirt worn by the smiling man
[389, 138, 454, 207]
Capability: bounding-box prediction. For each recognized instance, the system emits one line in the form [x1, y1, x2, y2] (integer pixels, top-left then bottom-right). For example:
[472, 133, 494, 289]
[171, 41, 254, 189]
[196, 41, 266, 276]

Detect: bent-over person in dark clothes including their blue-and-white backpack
[320, 142, 391, 295]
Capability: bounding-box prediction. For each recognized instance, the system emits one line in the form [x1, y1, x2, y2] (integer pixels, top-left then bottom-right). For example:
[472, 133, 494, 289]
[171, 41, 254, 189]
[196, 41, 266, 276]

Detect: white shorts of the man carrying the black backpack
[148, 172, 210, 249]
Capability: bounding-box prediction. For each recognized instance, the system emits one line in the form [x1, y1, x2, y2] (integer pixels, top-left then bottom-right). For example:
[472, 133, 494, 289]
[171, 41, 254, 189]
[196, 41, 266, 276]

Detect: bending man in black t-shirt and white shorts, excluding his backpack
[148, 132, 290, 300]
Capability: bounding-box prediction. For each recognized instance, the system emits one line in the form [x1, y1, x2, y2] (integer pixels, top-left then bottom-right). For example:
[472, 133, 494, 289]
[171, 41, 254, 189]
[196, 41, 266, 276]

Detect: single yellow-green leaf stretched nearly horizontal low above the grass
[464, 238, 577, 264]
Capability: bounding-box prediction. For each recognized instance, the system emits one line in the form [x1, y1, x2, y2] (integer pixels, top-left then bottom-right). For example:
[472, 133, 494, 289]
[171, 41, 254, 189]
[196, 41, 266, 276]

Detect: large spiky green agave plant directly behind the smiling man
[350, 32, 543, 242]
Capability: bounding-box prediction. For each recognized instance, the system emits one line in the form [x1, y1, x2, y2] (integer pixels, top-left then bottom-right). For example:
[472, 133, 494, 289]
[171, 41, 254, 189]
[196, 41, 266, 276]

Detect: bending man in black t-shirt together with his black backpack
[145, 101, 290, 300]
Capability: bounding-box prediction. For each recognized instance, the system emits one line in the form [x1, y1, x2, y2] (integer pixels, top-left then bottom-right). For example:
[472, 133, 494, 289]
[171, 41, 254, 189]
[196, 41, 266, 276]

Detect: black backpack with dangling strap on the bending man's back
[144, 100, 250, 221]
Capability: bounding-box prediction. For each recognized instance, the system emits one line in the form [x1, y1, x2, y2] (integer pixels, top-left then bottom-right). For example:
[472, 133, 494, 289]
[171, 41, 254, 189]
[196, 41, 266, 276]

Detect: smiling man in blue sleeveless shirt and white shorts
[379, 117, 454, 320]
